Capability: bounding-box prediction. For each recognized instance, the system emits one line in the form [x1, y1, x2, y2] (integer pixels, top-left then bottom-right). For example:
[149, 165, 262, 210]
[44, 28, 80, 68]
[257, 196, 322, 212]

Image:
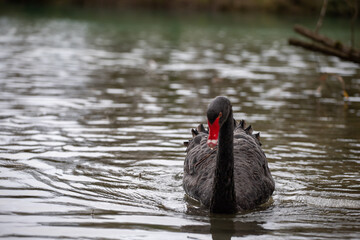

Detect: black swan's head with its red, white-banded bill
[207, 97, 231, 148]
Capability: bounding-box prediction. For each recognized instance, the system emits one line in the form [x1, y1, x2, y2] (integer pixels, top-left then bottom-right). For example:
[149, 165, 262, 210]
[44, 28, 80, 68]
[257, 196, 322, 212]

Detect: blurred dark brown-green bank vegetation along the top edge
[0, 0, 358, 17]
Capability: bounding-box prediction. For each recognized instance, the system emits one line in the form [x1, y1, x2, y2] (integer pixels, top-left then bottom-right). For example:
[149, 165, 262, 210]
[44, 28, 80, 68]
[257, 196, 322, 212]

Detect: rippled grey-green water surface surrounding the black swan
[0, 8, 360, 239]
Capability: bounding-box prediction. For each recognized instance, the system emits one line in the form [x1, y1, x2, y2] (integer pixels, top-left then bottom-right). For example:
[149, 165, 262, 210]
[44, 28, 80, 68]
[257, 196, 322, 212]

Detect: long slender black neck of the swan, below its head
[210, 110, 236, 213]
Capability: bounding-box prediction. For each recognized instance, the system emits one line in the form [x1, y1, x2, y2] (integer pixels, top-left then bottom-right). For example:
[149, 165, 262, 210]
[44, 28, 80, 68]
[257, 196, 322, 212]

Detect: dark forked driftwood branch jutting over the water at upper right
[289, 25, 360, 63]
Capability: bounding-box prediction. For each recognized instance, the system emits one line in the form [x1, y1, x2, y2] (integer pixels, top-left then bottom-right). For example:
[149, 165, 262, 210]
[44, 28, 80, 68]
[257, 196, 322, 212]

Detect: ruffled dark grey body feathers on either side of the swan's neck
[183, 120, 275, 210]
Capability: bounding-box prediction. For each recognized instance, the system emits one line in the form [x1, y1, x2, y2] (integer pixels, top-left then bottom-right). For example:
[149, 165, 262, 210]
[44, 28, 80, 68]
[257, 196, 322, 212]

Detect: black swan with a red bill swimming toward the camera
[183, 96, 275, 213]
